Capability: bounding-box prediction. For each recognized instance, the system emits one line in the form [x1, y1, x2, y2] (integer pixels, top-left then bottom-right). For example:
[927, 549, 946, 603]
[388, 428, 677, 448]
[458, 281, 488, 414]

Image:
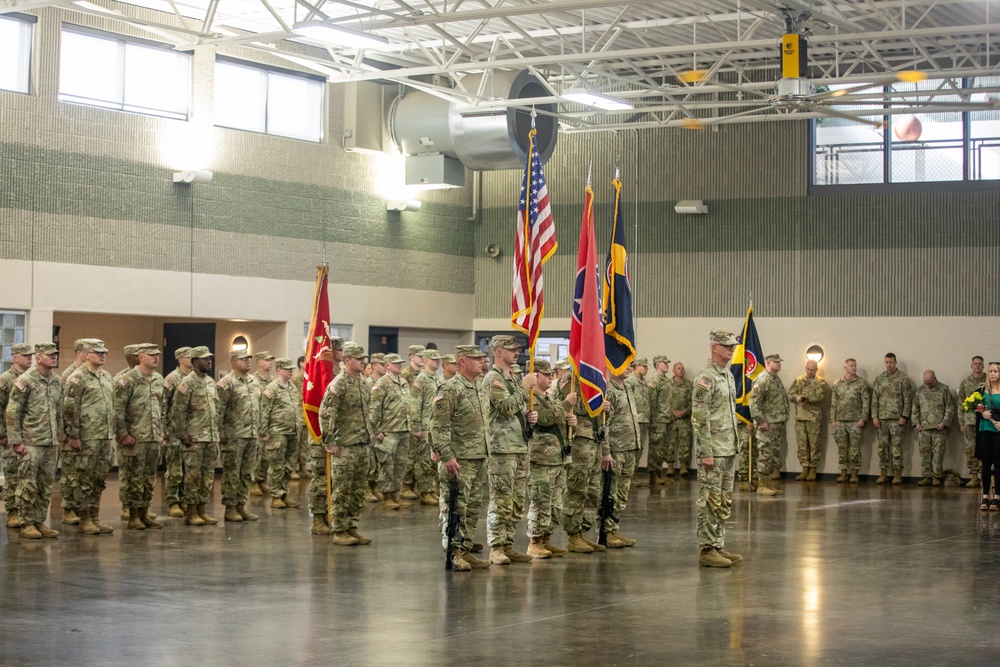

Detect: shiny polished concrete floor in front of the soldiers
[0, 472, 1000, 667]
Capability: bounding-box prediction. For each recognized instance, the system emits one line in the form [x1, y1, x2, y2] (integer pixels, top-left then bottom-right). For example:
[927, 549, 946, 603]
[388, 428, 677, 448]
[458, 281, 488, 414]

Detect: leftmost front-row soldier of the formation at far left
[4, 343, 66, 540]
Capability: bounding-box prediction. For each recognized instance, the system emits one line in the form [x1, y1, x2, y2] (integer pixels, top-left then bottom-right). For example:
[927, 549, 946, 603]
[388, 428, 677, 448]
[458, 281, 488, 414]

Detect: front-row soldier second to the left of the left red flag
[215, 349, 267, 523]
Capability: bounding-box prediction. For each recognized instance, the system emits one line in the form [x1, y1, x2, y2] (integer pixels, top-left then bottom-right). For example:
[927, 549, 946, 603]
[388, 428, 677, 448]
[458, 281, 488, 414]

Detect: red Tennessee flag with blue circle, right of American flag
[569, 183, 608, 417]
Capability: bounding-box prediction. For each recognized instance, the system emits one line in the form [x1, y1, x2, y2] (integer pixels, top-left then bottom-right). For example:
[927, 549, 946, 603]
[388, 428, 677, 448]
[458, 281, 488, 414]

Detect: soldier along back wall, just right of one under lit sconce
[830, 359, 872, 484]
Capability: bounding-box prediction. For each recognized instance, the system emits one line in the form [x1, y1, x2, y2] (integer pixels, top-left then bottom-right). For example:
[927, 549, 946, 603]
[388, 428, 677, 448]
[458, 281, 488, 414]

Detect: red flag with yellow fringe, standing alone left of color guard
[302, 264, 334, 442]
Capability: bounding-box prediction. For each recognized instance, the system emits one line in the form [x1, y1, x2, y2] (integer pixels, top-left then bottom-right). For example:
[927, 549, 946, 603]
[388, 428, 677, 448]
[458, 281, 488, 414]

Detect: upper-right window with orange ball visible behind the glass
[812, 77, 1000, 186]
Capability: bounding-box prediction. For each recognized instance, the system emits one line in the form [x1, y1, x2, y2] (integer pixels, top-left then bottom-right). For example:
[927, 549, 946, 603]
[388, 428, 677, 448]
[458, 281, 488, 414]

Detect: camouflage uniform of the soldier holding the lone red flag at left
[318, 370, 375, 533]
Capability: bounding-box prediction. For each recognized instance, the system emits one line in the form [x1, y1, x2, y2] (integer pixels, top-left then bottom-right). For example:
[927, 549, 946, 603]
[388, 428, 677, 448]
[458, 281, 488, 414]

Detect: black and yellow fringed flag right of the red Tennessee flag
[602, 174, 635, 375]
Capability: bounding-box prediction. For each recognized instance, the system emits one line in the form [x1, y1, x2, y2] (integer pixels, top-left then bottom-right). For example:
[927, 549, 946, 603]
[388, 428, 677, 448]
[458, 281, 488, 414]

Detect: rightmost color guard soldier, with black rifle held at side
[601, 369, 640, 549]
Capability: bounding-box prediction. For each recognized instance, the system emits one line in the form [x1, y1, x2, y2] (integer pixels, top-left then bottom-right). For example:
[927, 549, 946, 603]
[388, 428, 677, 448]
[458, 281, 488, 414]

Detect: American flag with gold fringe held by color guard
[510, 117, 559, 349]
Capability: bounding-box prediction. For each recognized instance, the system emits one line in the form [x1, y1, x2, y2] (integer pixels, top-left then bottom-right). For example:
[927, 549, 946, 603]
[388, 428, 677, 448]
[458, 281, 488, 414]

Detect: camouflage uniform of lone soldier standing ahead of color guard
[691, 361, 740, 549]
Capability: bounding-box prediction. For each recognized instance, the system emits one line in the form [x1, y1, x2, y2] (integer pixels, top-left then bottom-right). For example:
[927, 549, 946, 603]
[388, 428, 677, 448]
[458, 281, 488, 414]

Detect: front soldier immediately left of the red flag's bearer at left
[260, 357, 302, 509]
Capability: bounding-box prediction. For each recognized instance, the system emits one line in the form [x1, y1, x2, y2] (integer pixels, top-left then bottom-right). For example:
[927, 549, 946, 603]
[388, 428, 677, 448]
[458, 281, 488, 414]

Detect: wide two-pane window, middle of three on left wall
[59, 25, 191, 119]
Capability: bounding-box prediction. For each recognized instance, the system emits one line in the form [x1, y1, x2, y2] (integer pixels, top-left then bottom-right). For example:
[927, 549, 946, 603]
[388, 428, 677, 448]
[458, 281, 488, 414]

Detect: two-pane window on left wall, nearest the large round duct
[215, 58, 324, 141]
